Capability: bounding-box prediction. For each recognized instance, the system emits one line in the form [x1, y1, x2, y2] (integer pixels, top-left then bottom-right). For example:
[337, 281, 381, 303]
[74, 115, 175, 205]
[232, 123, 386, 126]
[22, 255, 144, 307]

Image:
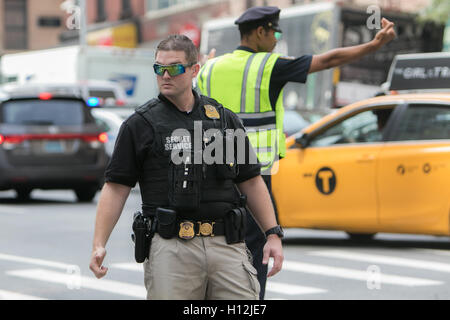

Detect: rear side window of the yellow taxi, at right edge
[393, 104, 450, 141]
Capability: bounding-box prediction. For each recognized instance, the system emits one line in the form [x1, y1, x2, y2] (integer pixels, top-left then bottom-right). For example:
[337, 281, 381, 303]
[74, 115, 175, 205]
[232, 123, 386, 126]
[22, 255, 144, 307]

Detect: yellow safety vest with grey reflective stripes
[197, 50, 286, 172]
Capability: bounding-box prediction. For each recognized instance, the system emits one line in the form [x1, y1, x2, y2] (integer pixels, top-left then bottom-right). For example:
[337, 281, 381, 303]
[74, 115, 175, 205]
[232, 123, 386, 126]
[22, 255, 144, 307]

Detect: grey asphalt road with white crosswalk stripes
[0, 191, 450, 300]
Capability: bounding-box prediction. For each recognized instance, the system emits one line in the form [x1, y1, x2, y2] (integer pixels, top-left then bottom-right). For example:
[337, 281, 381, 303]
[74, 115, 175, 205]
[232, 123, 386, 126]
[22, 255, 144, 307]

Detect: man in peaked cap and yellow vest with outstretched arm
[197, 7, 395, 299]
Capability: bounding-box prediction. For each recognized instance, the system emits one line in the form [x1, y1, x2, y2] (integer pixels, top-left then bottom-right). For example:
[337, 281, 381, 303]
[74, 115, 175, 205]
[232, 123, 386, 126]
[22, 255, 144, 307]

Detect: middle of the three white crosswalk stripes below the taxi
[282, 260, 442, 287]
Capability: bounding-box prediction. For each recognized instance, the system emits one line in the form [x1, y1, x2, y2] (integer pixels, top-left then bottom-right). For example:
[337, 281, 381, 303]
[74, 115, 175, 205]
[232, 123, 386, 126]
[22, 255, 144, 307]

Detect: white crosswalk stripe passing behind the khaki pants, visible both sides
[111, 263, 327, 295]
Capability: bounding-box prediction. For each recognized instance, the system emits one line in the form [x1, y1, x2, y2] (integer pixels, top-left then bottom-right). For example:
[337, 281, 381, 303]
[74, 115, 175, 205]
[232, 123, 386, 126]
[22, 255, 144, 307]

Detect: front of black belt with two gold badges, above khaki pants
[158, 220, 225, 240]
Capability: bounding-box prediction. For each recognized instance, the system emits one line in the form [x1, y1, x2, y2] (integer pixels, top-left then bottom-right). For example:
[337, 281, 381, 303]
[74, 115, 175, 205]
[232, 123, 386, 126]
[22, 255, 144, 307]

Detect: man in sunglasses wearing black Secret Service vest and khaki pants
[90, 35, 283, 300]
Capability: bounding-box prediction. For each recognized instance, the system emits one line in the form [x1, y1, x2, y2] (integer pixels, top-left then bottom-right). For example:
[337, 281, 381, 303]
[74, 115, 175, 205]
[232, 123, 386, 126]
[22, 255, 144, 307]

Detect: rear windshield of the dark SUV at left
[2, 99, 83, 126]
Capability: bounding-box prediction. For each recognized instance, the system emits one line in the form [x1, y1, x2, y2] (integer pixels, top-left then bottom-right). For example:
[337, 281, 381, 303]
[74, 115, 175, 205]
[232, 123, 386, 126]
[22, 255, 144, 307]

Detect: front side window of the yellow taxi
[310, 106, 393, 147]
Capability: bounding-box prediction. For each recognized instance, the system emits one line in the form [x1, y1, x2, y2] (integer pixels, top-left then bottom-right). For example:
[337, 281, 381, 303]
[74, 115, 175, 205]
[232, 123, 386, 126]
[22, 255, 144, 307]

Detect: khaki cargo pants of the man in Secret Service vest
[144, 234, 260, 300]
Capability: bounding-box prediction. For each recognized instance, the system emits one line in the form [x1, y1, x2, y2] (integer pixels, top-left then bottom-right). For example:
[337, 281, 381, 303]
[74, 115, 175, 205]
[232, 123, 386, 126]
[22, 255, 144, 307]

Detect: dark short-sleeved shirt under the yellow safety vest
[237, 46, 312, 109]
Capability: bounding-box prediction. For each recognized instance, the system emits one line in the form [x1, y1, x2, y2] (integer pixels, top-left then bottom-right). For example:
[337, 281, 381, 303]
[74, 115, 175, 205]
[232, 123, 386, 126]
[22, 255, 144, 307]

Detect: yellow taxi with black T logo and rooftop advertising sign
[272, 53, 450, 239]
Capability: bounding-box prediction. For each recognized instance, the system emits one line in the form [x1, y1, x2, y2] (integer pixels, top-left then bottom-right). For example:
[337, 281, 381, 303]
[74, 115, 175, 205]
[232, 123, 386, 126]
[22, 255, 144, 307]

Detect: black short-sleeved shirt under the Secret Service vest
[105, 91, 261, 187]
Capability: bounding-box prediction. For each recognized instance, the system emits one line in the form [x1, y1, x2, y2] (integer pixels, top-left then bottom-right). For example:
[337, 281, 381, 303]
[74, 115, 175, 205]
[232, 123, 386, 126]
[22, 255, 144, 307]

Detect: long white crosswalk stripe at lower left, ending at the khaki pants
[6, 269, 147, 299]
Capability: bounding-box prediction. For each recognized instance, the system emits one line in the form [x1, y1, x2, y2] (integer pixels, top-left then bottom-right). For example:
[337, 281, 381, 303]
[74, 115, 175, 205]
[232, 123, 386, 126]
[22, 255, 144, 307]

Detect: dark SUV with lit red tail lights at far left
[0, 89, 107, 201]
